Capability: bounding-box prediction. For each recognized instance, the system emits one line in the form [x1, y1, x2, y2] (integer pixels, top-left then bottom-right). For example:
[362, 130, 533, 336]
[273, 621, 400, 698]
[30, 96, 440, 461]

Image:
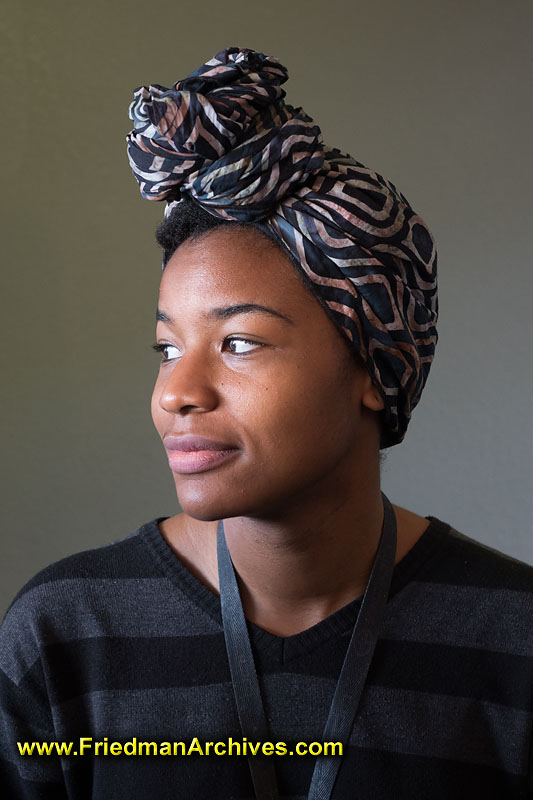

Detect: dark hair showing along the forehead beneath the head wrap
[156, 197, 384, 465]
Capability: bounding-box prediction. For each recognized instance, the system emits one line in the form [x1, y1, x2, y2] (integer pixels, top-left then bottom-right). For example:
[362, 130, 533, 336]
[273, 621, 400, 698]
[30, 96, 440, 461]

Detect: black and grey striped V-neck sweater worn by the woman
[0, 516, 533, 800]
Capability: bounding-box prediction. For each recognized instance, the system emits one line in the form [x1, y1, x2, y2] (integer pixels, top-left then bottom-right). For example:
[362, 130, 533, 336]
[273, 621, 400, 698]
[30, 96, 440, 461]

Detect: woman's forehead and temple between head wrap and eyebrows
[158, 229, 360, 369]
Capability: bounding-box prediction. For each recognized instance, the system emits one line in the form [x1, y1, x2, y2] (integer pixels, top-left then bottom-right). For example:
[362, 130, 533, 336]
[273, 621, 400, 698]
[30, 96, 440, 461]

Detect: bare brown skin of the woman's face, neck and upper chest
[152, 228, 429, 636]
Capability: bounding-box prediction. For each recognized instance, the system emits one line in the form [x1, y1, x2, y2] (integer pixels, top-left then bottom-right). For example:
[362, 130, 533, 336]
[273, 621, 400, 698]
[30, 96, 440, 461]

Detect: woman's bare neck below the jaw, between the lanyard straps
[224, 488, 383, 636]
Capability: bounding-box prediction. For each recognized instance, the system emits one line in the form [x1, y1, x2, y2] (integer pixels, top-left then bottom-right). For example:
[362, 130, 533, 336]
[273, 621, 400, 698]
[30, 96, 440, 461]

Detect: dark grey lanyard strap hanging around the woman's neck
[217, 492, 396, 800]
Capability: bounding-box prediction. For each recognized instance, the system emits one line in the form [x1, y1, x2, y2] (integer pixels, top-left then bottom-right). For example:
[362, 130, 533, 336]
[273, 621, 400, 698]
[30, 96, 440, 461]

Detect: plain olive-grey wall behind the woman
[0, 0, 533, 610]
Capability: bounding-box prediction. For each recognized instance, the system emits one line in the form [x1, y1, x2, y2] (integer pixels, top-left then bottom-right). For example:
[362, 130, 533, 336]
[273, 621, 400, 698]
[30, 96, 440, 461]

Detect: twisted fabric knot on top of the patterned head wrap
[127, 47, 324, 220]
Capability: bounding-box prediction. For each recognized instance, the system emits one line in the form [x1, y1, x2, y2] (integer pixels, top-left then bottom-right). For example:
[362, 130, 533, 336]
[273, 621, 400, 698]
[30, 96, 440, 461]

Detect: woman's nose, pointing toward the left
[159, 350, 218, 414]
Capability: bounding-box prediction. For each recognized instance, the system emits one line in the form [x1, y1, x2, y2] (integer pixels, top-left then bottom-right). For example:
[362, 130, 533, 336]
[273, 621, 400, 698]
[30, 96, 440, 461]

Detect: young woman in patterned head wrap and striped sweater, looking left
[0, 48, 533, 800]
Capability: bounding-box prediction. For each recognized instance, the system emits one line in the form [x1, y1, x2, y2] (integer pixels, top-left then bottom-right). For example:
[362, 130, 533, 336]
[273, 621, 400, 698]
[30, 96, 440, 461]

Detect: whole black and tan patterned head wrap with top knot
[127, 47, 438, 447]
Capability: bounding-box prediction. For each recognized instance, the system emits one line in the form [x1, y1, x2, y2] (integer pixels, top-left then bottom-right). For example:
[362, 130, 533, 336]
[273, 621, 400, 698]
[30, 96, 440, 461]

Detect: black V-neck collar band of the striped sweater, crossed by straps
[138, 516, 450, 662]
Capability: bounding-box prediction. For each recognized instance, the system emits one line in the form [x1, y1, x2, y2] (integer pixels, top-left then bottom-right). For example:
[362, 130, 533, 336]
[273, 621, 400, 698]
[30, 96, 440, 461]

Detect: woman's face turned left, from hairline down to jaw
[152, 228, 379, 520]
